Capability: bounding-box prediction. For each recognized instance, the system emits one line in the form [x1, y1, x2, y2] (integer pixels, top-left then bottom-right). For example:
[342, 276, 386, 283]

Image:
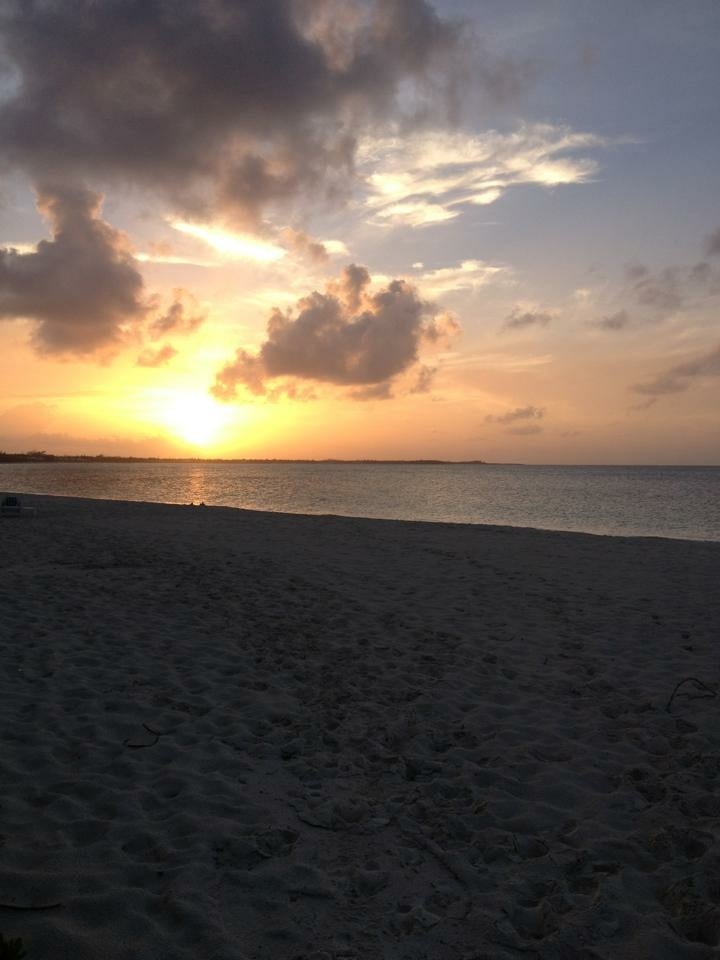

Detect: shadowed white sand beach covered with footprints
[0, 497, 720, 960]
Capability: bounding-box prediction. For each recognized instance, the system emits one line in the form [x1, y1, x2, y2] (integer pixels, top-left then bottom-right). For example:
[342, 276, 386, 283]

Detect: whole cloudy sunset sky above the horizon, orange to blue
[0, 0, 720, 464]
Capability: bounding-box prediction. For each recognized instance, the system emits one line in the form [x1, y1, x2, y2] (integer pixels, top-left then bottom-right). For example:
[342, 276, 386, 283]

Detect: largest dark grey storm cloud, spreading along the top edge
[0, 0, 462, 223]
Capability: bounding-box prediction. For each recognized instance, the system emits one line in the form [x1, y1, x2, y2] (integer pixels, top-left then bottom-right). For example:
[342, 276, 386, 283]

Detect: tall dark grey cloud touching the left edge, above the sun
[0, 185, 147, 354]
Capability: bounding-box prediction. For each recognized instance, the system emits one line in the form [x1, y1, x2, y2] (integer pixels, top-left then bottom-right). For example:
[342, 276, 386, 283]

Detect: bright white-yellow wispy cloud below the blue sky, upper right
[358, 124, 609, 227]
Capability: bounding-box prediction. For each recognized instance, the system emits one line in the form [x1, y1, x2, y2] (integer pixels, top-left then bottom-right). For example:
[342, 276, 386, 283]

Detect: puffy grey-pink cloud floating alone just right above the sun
[212, 264, 459, 400]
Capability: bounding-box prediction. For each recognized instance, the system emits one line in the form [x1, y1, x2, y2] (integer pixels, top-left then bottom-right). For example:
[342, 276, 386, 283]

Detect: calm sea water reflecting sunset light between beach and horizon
[0, 463, 720, 540]
